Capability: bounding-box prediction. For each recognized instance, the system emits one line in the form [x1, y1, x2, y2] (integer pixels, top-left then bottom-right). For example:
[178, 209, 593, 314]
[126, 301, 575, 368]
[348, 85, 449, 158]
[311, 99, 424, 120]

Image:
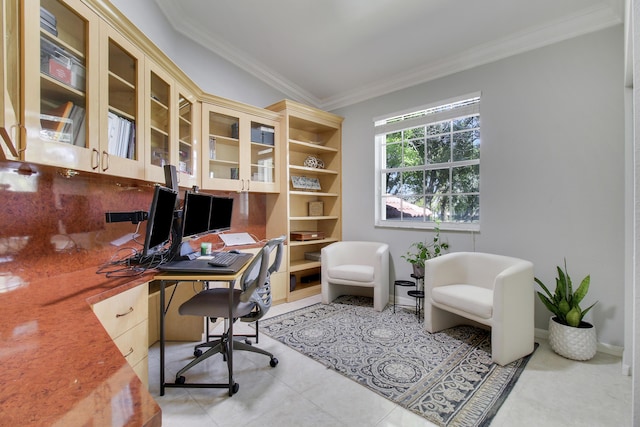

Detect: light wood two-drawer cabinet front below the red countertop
[93, 283, 149, 388]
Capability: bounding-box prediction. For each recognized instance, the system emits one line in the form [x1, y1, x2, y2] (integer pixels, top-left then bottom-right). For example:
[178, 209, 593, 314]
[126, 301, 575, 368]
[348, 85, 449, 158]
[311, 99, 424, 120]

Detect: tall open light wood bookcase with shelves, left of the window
[267, 100, 342, 301]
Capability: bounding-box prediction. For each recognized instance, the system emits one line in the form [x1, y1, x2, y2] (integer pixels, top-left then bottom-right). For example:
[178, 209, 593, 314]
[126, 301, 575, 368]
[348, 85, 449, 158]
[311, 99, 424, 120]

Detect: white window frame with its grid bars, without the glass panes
[373, 92, 482, 232]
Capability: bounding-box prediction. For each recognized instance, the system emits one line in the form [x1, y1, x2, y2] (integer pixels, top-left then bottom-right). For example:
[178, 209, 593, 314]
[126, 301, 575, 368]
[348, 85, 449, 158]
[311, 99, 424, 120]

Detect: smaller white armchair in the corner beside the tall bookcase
[321, 241, 389, 311]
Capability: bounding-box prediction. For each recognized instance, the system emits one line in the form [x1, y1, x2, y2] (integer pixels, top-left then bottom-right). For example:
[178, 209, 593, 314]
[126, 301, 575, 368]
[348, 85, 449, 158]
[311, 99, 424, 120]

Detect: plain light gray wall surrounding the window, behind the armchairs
[335, 26, 625, 346]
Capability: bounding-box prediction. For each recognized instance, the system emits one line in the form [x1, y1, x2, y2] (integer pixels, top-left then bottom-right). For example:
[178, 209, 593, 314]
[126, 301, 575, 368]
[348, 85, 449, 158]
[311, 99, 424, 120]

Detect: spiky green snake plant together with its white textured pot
[534, 259, 597, 360]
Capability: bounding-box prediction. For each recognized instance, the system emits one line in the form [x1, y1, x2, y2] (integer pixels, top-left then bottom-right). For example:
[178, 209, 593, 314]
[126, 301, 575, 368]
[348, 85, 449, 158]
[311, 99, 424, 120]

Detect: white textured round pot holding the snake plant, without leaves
[549, 317, 597, 360]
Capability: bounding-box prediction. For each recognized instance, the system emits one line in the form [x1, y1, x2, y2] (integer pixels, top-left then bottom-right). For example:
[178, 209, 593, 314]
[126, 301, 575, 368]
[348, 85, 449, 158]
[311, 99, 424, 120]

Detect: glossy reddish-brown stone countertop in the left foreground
[0, 268, 162, 426]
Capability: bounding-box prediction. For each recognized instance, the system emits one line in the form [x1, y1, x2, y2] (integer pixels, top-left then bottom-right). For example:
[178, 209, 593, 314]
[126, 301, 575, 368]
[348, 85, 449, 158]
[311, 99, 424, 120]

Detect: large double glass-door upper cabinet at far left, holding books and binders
[19, 0, 144, 179]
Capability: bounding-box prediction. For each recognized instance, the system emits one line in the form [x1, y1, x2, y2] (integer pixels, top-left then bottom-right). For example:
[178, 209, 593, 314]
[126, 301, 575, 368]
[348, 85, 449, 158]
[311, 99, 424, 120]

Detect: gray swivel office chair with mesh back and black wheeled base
[176, 236, 284, 396]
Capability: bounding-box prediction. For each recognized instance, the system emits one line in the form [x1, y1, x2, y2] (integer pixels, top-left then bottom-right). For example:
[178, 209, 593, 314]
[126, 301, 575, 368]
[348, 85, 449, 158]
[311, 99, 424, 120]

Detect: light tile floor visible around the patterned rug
[149, 296, 631, 427]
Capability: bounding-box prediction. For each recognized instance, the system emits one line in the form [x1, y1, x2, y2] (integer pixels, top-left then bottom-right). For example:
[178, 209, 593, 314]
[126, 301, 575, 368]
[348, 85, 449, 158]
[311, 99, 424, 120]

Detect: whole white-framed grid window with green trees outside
[375, 94, 480, 230]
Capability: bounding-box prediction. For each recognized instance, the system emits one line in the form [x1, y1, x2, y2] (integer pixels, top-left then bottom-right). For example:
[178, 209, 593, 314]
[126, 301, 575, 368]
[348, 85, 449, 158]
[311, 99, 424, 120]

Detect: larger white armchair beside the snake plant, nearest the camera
[424, 252, 534, 365]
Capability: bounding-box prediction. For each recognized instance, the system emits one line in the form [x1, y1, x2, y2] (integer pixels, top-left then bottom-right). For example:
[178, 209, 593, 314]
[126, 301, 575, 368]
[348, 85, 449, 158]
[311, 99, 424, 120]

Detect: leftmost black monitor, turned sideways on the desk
[142, 186, 178, 256]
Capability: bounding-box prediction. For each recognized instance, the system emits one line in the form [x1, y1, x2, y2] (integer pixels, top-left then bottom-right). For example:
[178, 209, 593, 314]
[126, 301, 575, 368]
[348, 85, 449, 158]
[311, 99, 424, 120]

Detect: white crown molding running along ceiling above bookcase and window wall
[157, 0, 623, 111]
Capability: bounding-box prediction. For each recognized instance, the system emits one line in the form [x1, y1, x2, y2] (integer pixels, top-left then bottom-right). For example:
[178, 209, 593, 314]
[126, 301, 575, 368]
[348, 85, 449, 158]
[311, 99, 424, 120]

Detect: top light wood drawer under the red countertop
[93, 283, 149, 342]
